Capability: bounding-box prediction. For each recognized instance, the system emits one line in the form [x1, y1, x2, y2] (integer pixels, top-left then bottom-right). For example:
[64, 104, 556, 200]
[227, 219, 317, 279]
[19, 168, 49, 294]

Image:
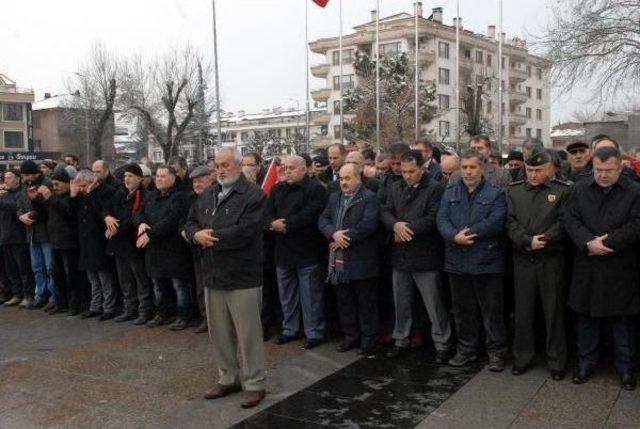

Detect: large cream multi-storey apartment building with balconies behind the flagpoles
[310, 3, 550, 153]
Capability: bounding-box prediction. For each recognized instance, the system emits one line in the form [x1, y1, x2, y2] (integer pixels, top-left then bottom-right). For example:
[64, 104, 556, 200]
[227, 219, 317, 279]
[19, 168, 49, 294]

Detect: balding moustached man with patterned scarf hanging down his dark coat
[318, 164, 380, 354]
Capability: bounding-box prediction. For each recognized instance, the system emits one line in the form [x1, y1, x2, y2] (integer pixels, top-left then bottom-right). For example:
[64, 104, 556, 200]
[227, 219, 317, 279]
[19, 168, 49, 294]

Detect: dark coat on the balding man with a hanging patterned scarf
[318, 186, 380, 280]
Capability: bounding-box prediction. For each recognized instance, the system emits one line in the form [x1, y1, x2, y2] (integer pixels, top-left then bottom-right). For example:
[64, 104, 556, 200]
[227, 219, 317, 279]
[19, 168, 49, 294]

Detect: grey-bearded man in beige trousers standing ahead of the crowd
[184, 149, 266, 408]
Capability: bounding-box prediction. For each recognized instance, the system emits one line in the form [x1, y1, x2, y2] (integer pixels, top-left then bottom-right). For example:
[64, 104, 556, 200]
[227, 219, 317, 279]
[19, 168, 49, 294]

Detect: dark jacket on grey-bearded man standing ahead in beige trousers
[184, 176, 266, 290]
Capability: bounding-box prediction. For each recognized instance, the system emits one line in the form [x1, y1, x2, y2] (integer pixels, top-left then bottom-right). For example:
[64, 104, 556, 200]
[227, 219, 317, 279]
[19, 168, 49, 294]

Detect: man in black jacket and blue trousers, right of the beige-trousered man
[267, 156, 326, 349]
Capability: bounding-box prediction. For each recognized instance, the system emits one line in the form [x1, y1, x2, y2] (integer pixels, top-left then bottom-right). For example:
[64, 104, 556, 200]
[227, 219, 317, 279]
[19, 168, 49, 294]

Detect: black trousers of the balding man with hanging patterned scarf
[335, 277, 378, 348]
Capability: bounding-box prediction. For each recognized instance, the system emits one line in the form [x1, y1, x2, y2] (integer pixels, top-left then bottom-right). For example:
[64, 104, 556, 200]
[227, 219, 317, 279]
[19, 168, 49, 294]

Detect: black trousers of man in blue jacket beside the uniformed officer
[449, 274, 507, 357]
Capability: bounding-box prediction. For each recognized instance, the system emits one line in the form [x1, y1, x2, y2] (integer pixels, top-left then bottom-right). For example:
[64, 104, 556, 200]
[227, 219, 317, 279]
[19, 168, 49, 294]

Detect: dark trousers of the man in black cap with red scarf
[116, 256, 153, 316]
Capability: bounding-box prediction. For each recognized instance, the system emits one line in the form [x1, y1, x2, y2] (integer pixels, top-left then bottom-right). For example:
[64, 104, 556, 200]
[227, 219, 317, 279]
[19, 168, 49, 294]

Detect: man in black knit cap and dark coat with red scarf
[104, 164, 153, 325]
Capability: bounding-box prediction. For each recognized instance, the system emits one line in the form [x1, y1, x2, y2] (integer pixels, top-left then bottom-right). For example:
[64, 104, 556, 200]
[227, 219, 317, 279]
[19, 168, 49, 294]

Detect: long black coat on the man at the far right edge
[565, 176, 640, 317]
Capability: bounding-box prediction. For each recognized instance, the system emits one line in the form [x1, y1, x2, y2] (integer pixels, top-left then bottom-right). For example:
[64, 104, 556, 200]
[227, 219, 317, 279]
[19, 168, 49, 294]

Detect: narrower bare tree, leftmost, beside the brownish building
[63, 42, 120, 164]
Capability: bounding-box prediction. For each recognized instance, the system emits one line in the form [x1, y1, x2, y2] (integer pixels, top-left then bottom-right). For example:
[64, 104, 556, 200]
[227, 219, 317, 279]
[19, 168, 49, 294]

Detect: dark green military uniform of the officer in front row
[507, 160, 570, 371]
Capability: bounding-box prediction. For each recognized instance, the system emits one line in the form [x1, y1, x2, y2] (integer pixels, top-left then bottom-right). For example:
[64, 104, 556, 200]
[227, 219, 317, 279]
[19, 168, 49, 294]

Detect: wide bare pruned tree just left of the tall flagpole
[121, 46, 212, 162]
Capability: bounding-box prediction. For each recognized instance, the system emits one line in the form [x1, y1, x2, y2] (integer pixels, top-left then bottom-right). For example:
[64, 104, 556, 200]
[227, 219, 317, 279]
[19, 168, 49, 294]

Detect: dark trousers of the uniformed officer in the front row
[513, 254, 567, 371]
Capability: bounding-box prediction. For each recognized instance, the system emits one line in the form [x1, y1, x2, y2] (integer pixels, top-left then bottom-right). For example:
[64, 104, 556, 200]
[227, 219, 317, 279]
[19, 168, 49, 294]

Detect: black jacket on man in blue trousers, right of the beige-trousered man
[267, 177, 327, 268]
